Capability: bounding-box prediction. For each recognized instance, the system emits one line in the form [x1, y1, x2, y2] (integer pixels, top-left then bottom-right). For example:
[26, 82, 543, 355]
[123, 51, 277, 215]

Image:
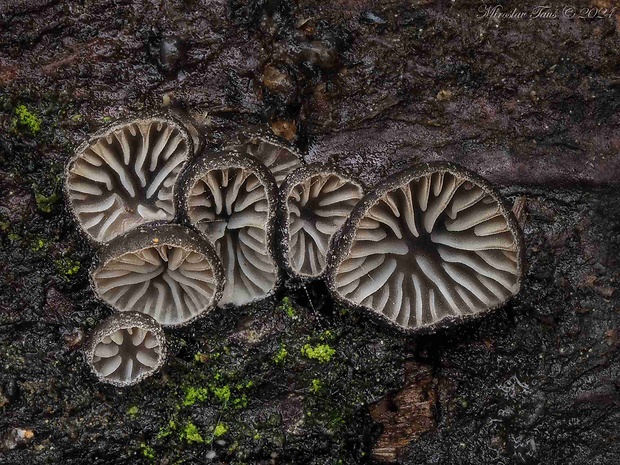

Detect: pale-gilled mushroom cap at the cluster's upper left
[65, 116, 193, 243]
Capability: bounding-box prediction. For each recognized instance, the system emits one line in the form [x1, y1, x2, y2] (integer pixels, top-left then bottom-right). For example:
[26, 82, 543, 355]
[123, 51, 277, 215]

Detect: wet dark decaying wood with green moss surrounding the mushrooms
[0, 0, 620, 465]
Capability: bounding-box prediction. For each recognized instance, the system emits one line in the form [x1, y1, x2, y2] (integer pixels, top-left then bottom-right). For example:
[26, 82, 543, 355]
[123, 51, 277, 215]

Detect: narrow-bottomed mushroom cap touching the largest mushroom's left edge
[277, 164, 364, 278]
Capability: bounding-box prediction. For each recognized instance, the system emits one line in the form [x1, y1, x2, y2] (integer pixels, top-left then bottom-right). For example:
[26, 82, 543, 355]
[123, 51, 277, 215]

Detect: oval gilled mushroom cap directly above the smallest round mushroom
[91, 224, 225, 327]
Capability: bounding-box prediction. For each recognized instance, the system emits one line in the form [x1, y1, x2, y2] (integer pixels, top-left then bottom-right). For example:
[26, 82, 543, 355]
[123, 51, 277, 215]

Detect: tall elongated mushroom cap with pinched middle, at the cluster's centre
[179, 151, 280, 306]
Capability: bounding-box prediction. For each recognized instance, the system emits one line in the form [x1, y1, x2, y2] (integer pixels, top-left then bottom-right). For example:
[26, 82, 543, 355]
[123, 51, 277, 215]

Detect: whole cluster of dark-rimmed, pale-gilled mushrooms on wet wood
[65, 115, 523, 386]
